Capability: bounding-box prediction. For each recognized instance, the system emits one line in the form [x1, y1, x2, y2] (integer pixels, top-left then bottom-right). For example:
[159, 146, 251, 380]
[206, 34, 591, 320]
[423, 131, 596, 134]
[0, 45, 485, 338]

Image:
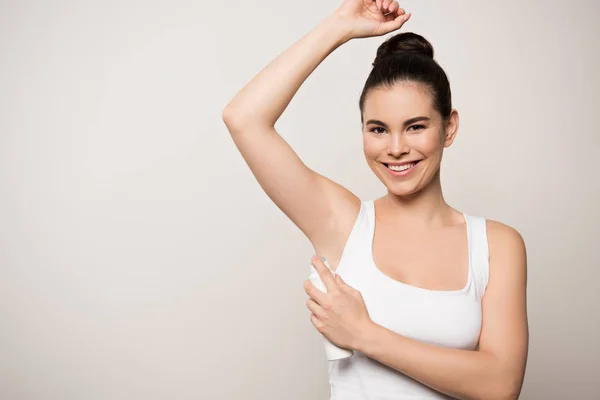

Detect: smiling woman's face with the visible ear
[363, 82, 458, 196]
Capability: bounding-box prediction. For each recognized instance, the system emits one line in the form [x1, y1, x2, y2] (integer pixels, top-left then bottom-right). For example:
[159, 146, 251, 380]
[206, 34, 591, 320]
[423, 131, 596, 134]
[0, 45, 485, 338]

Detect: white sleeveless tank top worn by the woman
[329, 200, 489, 400]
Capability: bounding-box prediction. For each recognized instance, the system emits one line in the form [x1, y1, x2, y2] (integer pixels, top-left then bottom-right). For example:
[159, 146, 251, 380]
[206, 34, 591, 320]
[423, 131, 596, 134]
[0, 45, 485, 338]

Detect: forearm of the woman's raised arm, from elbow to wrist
[224, 14, 350, 126]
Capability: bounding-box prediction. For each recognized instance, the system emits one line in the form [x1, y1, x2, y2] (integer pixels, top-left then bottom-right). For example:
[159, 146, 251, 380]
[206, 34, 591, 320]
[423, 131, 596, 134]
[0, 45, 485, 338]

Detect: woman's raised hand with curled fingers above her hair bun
[335, 0, 411, 38]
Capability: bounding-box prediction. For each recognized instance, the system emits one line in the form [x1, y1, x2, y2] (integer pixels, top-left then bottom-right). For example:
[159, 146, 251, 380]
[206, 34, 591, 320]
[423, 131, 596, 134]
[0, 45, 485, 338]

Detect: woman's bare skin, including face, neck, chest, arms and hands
[223, 0, 528, 399]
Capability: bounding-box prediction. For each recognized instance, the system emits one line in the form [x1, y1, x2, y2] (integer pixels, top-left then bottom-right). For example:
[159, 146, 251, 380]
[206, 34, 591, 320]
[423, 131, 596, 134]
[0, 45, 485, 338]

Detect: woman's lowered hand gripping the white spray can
[304, 257, 373, 349]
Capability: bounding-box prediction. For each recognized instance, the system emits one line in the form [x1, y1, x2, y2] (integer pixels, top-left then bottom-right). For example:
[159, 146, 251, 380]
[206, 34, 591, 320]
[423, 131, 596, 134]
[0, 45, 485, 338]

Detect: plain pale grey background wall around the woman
[0, 0, 600, 400]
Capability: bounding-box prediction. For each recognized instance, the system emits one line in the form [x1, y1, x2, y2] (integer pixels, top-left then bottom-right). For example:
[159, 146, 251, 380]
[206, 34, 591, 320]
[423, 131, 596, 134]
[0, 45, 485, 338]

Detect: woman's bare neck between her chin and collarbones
[381, 170, 454, 228]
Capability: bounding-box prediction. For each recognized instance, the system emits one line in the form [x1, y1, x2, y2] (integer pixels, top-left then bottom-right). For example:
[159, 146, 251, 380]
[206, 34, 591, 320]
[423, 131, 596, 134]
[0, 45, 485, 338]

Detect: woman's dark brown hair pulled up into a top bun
[359, 32, 452, 122]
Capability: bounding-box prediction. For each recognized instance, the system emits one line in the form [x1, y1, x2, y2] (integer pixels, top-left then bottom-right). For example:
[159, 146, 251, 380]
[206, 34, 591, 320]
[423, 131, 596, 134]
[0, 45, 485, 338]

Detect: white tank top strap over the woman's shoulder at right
[465, 215, 490, 301]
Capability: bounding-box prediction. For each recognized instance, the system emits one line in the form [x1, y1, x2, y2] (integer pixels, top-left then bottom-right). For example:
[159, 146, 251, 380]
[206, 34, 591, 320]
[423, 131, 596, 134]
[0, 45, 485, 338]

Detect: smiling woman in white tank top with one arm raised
[223, 0, 528, 400]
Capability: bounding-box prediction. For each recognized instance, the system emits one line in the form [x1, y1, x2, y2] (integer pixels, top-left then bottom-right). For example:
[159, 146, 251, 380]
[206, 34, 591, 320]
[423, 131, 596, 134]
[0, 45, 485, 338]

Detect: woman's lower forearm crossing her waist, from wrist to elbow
[355, 323, 516, 400]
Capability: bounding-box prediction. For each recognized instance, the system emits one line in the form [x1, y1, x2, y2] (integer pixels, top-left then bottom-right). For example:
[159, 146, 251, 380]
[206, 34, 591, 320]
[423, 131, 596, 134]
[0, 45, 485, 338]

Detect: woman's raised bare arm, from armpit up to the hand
[223, 0, 412, 268]
